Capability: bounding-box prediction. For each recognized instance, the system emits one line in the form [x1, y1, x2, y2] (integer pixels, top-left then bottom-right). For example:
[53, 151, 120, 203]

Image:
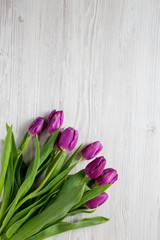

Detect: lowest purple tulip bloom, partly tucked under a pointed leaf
[86, 192, 108, 209]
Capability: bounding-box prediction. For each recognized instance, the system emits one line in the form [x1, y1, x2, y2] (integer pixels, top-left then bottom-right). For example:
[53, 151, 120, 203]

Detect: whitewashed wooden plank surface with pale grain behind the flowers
[0, 0, 160, 240]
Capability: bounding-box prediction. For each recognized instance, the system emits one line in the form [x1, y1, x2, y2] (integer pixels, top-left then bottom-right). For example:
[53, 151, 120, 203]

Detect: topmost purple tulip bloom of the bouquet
[46, 110, 64, 133]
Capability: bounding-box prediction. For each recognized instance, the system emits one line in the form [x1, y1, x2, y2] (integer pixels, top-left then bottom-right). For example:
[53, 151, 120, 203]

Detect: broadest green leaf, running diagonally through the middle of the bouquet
[11, 185, 84, 240]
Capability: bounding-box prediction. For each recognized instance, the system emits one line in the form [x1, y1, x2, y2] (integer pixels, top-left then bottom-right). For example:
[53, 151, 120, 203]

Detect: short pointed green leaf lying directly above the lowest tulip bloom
[72, 184, 112, 210]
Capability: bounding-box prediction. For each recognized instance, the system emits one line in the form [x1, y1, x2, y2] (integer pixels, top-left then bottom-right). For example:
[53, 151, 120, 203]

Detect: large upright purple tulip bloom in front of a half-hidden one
[58, 127, 78, 151]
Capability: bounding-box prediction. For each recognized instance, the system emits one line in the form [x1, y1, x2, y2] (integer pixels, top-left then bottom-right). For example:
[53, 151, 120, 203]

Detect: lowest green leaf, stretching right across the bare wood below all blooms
[27, 217, 109, 240]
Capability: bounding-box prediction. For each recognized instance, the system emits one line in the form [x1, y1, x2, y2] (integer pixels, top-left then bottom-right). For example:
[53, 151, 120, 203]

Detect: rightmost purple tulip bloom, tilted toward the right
[96, 168, 118, 185]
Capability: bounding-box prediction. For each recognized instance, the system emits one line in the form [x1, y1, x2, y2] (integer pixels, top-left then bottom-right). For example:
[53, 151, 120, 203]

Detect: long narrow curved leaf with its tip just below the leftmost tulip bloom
[0, 135, 40, 233]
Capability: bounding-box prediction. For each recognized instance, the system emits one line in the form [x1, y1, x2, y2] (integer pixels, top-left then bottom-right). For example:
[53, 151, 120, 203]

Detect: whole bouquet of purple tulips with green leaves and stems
[0, 110, 118, 240]
